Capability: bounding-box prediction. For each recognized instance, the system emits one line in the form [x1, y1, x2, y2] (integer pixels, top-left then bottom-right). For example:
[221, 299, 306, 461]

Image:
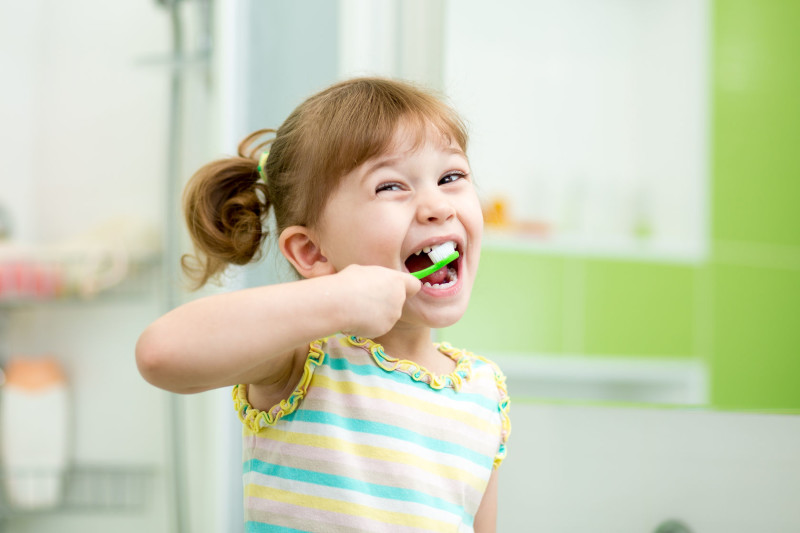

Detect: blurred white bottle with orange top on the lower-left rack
[0, 357, 69, 509]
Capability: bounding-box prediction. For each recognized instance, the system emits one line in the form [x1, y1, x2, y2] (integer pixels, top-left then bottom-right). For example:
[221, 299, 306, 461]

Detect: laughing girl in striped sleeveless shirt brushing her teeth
[136, 78, 510, 533]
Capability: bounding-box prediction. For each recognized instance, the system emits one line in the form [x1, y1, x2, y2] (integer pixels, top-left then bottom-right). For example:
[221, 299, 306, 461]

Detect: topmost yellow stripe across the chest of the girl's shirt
[314, 374, 498, 436]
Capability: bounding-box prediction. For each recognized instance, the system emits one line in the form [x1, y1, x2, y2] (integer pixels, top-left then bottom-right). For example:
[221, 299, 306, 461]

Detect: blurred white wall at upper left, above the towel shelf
[0, 0, 169, 240]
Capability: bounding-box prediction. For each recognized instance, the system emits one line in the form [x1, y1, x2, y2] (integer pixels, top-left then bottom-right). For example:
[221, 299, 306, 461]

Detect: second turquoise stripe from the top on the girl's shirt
[284, 409, 494, 468]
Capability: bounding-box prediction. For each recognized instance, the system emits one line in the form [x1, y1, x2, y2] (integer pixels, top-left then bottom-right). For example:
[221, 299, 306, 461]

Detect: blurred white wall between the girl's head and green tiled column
[444, 0, 710, 258]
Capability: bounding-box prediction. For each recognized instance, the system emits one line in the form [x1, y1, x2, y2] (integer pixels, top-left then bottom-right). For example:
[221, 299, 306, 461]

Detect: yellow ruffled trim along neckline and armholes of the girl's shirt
[232, 337, 511, 468]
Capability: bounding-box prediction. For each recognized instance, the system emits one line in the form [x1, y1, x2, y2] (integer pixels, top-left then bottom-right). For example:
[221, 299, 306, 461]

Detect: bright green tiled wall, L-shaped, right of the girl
[442, 0, 800, 409]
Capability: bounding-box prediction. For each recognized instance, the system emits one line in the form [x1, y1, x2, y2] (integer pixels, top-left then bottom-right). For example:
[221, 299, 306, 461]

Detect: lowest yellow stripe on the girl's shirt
[244, 484, 453, 533]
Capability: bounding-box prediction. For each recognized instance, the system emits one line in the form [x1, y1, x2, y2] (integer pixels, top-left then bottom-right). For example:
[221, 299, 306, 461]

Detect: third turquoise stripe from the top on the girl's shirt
[245, 459, 472, 523]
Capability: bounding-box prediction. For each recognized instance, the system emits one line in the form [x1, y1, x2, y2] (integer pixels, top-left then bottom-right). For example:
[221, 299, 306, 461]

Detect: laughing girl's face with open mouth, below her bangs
[317, 128, 483, 327]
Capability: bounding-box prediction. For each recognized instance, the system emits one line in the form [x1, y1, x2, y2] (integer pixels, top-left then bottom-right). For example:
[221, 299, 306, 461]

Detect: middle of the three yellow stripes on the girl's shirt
[245, 428, 486, 493]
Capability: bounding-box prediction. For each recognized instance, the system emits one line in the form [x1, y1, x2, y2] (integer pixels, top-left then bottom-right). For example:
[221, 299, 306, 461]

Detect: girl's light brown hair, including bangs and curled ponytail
[182, 78, 468, 288]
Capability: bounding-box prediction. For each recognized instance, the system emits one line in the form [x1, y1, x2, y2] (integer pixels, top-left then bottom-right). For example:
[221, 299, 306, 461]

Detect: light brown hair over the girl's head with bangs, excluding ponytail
[267, 78, 468, 229]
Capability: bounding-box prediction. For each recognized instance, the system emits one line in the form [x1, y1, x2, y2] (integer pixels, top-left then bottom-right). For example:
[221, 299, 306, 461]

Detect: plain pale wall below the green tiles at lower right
[498, 404, 800, 533]
